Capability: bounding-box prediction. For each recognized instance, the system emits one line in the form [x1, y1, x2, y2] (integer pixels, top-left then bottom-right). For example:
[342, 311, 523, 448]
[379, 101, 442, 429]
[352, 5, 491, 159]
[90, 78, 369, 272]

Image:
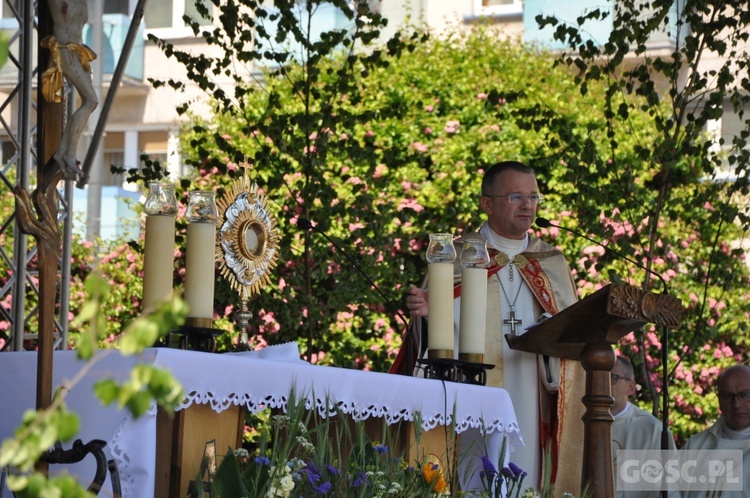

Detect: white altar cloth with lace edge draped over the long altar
[0, 348, 523, 498]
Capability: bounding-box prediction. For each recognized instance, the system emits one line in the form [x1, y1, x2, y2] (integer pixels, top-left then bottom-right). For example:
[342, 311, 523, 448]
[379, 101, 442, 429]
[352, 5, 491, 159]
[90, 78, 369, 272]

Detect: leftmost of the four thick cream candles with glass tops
[141, 182, 177, 313]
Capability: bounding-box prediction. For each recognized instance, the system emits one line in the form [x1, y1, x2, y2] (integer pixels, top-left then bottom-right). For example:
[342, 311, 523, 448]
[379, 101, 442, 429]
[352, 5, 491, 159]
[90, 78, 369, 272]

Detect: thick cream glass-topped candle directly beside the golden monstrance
[185, 190, 218, 328]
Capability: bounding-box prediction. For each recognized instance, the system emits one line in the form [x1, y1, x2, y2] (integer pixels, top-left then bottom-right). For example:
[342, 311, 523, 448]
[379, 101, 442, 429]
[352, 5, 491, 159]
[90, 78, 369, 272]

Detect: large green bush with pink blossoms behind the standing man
[6, 2, 749, 448]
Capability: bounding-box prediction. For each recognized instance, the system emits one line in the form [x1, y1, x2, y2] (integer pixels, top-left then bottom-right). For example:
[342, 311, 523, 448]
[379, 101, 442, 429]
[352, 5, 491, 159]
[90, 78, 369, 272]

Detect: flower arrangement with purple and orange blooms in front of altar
[190, 394, 450, 498]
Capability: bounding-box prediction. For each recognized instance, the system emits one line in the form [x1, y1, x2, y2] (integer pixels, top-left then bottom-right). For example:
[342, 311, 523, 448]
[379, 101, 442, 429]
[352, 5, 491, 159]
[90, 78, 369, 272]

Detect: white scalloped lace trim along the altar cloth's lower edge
[179, 391, 520, 439]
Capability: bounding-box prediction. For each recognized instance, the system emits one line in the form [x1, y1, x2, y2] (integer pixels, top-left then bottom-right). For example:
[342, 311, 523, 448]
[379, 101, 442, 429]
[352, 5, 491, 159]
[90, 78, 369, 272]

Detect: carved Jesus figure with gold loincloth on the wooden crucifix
[41, 0, 99, 180]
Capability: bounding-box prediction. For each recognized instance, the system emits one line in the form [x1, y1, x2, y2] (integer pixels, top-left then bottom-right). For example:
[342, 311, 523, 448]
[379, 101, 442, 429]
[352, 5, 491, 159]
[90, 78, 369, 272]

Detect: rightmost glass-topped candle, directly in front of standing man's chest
[458, 233, 490, 363]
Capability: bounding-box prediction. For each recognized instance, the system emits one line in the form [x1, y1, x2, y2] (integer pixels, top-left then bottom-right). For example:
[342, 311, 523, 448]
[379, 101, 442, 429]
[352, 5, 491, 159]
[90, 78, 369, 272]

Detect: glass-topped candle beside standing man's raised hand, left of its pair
[427, 233, 456, 359]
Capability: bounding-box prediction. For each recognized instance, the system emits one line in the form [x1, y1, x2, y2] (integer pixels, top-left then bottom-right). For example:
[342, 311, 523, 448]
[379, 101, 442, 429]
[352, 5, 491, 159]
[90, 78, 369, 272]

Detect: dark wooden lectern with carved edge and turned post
[505, 284, 684, 498]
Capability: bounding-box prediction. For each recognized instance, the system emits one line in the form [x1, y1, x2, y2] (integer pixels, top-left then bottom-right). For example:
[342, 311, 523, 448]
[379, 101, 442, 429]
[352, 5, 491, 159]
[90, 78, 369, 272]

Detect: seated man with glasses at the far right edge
[682, 365, 750, 498]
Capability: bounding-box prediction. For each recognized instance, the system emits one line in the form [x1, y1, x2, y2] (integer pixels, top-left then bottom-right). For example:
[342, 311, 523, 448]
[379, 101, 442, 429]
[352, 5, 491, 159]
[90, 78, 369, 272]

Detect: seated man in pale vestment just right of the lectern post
[610, 356, 679, 498]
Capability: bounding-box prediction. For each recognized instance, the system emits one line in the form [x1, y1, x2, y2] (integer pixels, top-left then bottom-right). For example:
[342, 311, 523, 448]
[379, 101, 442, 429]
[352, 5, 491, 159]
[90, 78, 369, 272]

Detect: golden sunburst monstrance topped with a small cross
[216, 156, 279, 349]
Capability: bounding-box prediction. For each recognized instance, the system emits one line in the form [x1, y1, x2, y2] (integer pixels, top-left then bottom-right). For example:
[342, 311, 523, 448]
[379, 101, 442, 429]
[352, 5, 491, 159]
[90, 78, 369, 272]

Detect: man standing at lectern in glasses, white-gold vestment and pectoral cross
[406, 161, 585, 495]
